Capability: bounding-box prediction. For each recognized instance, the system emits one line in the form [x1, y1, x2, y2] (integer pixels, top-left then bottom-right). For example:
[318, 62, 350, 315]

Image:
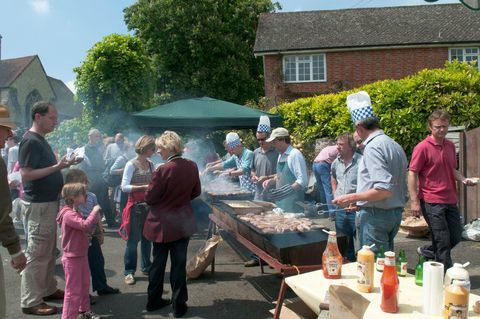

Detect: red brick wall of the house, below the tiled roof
[264, 47, 448, 106]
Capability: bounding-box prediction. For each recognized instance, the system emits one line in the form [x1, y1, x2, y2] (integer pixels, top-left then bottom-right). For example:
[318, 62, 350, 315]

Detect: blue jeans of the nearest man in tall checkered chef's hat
[358, 207, 403, 253]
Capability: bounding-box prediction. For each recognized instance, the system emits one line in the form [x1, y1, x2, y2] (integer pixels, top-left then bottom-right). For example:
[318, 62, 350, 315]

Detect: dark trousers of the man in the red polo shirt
[420, 201, 463, 270]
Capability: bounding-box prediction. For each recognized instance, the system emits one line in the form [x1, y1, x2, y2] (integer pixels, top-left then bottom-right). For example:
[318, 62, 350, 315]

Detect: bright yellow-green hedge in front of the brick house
[271, 61, 480, 161]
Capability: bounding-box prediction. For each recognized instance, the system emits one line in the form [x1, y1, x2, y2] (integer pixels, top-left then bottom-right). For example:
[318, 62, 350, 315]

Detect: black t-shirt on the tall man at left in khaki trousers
[18, 131, 63, 203]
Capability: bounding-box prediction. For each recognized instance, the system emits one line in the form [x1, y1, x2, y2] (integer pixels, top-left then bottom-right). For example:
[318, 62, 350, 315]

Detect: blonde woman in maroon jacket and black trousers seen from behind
[143, 131, 201, 318]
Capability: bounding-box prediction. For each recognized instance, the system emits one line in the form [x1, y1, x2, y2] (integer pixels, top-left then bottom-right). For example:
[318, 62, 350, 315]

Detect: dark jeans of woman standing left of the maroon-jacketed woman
[123, 207, 152, 276]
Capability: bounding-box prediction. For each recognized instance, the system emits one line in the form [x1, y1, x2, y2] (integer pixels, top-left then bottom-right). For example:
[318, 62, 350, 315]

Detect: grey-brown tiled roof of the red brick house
[254, 4, 480, 54]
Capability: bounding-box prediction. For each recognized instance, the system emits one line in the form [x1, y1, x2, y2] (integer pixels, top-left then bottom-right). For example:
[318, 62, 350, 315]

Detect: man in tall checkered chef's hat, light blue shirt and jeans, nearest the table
[333, 91, 408, 251]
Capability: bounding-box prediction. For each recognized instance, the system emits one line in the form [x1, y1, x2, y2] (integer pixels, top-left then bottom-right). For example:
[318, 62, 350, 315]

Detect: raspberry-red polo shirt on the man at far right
[409, 135, 457, 204]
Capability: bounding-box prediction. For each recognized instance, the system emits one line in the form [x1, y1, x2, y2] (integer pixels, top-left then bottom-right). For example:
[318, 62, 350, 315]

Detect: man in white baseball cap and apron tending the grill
[263, 127, 308, 213]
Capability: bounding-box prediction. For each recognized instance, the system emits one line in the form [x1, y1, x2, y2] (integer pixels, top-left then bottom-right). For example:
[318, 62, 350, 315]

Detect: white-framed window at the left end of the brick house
[283, 53, 327, 83]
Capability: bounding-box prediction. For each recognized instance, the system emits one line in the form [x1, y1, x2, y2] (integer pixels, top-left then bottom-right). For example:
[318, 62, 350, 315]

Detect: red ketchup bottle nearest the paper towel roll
[380, 251, 399, 313]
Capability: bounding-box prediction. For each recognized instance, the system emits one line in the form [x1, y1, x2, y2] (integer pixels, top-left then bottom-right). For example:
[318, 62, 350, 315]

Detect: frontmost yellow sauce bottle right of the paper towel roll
[443, 279, 470, 319]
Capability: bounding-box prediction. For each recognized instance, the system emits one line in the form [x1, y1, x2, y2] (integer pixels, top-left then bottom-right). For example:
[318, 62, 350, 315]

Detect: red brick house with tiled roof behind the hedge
[254, 4, 480, 106]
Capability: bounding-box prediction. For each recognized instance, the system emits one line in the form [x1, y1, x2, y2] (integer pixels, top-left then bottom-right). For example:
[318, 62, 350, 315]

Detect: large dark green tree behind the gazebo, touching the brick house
[124, 0, 280, 103]
